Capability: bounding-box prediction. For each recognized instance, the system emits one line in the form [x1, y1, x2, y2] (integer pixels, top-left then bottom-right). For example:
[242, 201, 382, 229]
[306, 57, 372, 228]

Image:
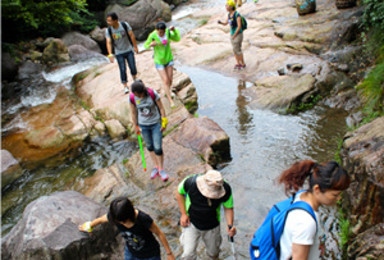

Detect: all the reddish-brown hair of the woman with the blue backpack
[278, 160, 350, 194]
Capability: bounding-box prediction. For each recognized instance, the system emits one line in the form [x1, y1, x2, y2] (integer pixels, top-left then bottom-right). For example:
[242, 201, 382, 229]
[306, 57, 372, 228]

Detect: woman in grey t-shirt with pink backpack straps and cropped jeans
[129, 80, 169, 181]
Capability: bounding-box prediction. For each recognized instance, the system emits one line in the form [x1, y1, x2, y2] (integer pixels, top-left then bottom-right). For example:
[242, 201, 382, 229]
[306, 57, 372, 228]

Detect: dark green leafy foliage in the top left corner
[1, 0, 96, 41]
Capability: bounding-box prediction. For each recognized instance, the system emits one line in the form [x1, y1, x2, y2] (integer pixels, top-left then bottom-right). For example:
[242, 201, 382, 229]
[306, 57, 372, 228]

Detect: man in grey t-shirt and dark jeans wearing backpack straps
[105, 13, 139, 94]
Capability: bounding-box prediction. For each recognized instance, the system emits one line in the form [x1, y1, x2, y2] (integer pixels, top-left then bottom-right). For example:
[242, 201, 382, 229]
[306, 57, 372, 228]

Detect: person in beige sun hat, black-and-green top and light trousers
[176, 170, 236, 260]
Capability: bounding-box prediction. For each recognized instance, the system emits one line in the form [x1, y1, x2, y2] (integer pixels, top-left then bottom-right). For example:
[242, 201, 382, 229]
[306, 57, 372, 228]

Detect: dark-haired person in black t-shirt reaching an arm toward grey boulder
[79, 197, 175, 260]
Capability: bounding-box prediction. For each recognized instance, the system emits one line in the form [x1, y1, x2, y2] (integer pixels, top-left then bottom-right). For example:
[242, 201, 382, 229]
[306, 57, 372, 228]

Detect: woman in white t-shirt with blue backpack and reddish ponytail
[250, 160, 350, 260]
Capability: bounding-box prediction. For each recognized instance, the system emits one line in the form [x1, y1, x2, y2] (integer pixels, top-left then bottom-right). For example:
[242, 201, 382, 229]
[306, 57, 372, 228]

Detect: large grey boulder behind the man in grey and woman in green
[105, 0, 172, 41]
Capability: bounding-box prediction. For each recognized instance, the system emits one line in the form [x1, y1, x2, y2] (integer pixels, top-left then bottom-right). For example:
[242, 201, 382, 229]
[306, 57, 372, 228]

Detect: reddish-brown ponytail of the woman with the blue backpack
[277, 160, 317, 194]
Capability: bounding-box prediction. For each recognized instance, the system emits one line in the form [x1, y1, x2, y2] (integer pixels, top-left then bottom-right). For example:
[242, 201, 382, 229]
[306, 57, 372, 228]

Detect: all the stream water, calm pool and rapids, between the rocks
[1, 0, 346, 259]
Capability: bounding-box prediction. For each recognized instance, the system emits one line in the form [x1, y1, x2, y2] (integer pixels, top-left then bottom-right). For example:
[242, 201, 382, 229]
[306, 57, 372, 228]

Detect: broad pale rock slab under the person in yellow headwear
[174, 0, 361, 112]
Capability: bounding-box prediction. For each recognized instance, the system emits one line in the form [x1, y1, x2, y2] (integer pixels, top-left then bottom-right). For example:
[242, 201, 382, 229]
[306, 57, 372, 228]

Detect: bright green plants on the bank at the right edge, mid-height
[357, 61, 384, 123]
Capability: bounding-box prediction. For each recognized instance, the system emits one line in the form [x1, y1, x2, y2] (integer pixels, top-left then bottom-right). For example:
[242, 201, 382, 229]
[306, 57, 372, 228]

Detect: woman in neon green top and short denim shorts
[144, 22, 180, 108]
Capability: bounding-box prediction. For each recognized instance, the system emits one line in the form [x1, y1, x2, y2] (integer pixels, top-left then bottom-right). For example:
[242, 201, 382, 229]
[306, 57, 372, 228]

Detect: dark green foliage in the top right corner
[363, 0, 384, 30]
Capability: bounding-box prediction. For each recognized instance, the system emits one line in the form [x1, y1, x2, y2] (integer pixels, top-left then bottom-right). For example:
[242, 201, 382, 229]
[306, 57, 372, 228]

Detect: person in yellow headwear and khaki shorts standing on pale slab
[218, 0, 246, 70]
